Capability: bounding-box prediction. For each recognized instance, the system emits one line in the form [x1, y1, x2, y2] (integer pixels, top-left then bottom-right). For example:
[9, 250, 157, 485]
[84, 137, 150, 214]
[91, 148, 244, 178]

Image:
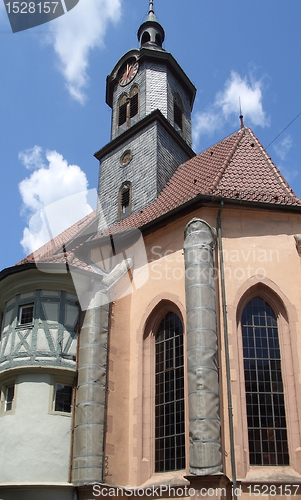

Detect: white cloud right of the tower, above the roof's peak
[193, 71, 269, 146]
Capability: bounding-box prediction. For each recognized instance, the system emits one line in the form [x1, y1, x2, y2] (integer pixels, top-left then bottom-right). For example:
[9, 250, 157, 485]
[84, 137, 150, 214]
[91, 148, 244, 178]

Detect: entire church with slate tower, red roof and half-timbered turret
[0, 0, 301, 500]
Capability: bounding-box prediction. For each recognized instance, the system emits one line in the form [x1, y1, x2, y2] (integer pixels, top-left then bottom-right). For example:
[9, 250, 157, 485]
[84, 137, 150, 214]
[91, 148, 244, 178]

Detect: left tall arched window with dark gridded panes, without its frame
[155, 312, 185, 472]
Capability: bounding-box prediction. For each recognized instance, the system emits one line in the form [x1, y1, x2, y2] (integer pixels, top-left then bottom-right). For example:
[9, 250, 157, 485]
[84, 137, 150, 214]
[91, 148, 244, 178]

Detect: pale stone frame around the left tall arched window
[141, 297, 189, 480]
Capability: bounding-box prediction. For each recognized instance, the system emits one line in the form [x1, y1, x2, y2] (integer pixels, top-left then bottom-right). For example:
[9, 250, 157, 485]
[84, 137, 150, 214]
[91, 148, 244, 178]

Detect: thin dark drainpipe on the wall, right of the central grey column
[217, 200, 237, 500]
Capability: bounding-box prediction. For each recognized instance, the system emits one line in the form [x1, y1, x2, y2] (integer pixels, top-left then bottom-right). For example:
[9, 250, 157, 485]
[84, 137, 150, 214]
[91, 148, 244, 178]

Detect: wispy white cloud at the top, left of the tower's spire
[49, 0, 121, 104]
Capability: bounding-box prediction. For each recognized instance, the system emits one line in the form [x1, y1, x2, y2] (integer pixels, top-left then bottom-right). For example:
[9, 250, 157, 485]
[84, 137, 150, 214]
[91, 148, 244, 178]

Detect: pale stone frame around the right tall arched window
[225, 277, 301, 479]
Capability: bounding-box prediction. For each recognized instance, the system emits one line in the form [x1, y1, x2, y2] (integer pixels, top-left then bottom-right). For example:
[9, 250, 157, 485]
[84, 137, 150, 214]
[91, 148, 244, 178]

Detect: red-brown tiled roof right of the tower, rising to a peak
[110, 128, 301, 231]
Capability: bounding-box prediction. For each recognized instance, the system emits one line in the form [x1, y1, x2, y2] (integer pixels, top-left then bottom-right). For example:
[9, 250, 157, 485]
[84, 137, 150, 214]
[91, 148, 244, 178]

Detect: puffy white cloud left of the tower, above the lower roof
[19, 146, 92, 254]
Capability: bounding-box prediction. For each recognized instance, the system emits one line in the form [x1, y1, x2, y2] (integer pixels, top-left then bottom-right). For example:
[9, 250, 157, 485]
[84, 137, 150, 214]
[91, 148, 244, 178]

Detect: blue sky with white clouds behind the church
[0, 0, 301, 269]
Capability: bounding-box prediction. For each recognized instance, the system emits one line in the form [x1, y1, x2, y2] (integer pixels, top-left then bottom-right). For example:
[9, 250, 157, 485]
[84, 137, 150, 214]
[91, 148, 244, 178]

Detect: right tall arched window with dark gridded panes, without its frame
[241, 297, 289, 465]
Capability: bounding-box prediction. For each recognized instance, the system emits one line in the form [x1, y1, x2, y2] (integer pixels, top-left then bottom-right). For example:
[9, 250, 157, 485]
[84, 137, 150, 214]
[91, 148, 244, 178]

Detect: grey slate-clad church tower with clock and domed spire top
[95, 1, 196, 229]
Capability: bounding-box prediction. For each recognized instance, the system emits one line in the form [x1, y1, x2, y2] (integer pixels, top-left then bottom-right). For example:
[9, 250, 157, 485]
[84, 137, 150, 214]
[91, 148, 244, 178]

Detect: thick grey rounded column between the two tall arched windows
[184, 218, 222, 476]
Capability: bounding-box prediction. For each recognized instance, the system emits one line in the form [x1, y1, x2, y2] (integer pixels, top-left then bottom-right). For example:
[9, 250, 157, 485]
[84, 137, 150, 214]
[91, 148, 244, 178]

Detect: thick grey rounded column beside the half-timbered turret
[72, 287, 109, 485]
